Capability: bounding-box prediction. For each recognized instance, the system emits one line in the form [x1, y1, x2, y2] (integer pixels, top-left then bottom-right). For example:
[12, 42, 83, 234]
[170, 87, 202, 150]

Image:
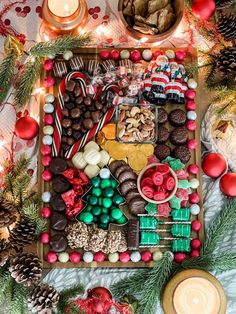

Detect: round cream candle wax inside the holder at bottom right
[173, 277, 221, 314]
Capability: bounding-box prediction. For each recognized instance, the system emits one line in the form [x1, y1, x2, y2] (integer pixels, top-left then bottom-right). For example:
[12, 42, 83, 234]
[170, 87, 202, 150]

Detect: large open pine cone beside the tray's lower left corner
[9, 252, 42, 287]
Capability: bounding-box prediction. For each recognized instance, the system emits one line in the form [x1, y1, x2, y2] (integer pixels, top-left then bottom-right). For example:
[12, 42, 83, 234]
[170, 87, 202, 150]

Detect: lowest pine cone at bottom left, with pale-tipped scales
[28, 283, 59, 314]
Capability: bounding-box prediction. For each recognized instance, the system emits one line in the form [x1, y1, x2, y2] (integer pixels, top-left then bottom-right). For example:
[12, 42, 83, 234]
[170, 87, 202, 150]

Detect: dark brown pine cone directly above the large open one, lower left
[10, 218, 36, 251]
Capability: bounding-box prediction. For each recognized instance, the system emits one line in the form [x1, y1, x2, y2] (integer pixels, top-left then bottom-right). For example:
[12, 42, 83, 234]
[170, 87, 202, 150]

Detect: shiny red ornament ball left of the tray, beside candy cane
[15, 116, 39, 140]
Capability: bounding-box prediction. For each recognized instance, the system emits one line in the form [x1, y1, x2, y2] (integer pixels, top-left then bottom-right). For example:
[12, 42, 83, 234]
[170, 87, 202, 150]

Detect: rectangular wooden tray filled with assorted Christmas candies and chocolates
[38, 48, 204, 268]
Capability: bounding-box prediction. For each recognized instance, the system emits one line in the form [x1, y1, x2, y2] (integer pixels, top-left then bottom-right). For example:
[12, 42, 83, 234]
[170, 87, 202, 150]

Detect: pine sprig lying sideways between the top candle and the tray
[30, 33, 91, 57]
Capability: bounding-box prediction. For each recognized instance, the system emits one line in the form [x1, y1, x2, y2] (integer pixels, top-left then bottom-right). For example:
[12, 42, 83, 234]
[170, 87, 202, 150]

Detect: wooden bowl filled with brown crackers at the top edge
[118, 0, 184, 42]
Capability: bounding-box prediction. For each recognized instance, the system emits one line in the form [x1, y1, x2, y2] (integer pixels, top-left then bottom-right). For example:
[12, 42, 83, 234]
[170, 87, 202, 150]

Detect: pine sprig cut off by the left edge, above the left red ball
[0, 51, 17, 103]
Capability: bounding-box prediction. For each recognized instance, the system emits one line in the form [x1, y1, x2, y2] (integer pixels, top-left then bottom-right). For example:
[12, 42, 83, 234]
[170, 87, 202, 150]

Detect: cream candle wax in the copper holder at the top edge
[48, 0, 79, 17]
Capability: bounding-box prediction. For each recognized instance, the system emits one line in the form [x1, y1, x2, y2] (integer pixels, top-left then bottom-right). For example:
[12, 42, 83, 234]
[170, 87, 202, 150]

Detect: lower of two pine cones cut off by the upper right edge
[216, 46, 236, 79]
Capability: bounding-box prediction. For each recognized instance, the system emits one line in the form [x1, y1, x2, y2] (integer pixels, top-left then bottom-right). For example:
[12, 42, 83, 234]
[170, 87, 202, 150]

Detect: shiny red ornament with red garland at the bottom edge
[65, 297, 133, 314]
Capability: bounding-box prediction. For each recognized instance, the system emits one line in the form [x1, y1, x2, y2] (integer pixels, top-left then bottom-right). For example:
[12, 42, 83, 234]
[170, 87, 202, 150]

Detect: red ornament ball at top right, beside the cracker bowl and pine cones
[191, 0, 216, 21]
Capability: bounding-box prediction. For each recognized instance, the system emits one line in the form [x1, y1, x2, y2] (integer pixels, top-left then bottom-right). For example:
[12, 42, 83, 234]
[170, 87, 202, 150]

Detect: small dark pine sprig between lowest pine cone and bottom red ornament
[57, 284, 84, 314]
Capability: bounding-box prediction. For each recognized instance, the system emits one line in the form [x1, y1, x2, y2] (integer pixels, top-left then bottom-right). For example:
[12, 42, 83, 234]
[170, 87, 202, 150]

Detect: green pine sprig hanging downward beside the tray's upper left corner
[15, 57, 42, 108]
